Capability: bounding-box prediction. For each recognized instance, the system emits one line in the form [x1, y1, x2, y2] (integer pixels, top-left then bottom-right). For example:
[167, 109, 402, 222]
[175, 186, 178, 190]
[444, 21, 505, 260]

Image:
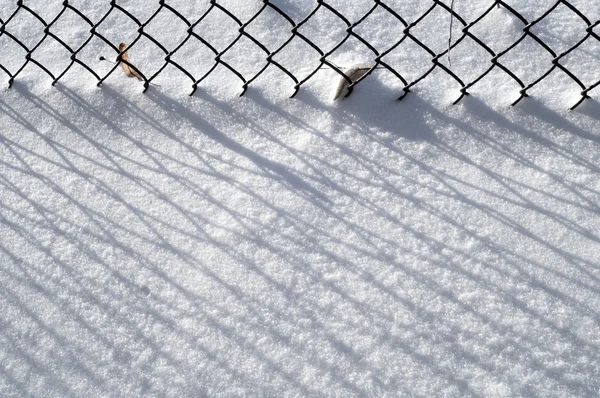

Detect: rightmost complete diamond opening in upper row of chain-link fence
[530, 4, 588, 54]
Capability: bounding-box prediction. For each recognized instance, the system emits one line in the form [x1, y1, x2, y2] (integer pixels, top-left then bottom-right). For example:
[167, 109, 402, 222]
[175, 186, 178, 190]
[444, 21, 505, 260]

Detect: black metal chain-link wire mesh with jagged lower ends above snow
[0, 0, 600, 108]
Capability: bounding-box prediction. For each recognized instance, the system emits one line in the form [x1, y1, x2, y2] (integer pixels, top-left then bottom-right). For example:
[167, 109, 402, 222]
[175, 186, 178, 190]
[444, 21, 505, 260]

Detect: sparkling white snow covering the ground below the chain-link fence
[0, 0, 600, 397]
